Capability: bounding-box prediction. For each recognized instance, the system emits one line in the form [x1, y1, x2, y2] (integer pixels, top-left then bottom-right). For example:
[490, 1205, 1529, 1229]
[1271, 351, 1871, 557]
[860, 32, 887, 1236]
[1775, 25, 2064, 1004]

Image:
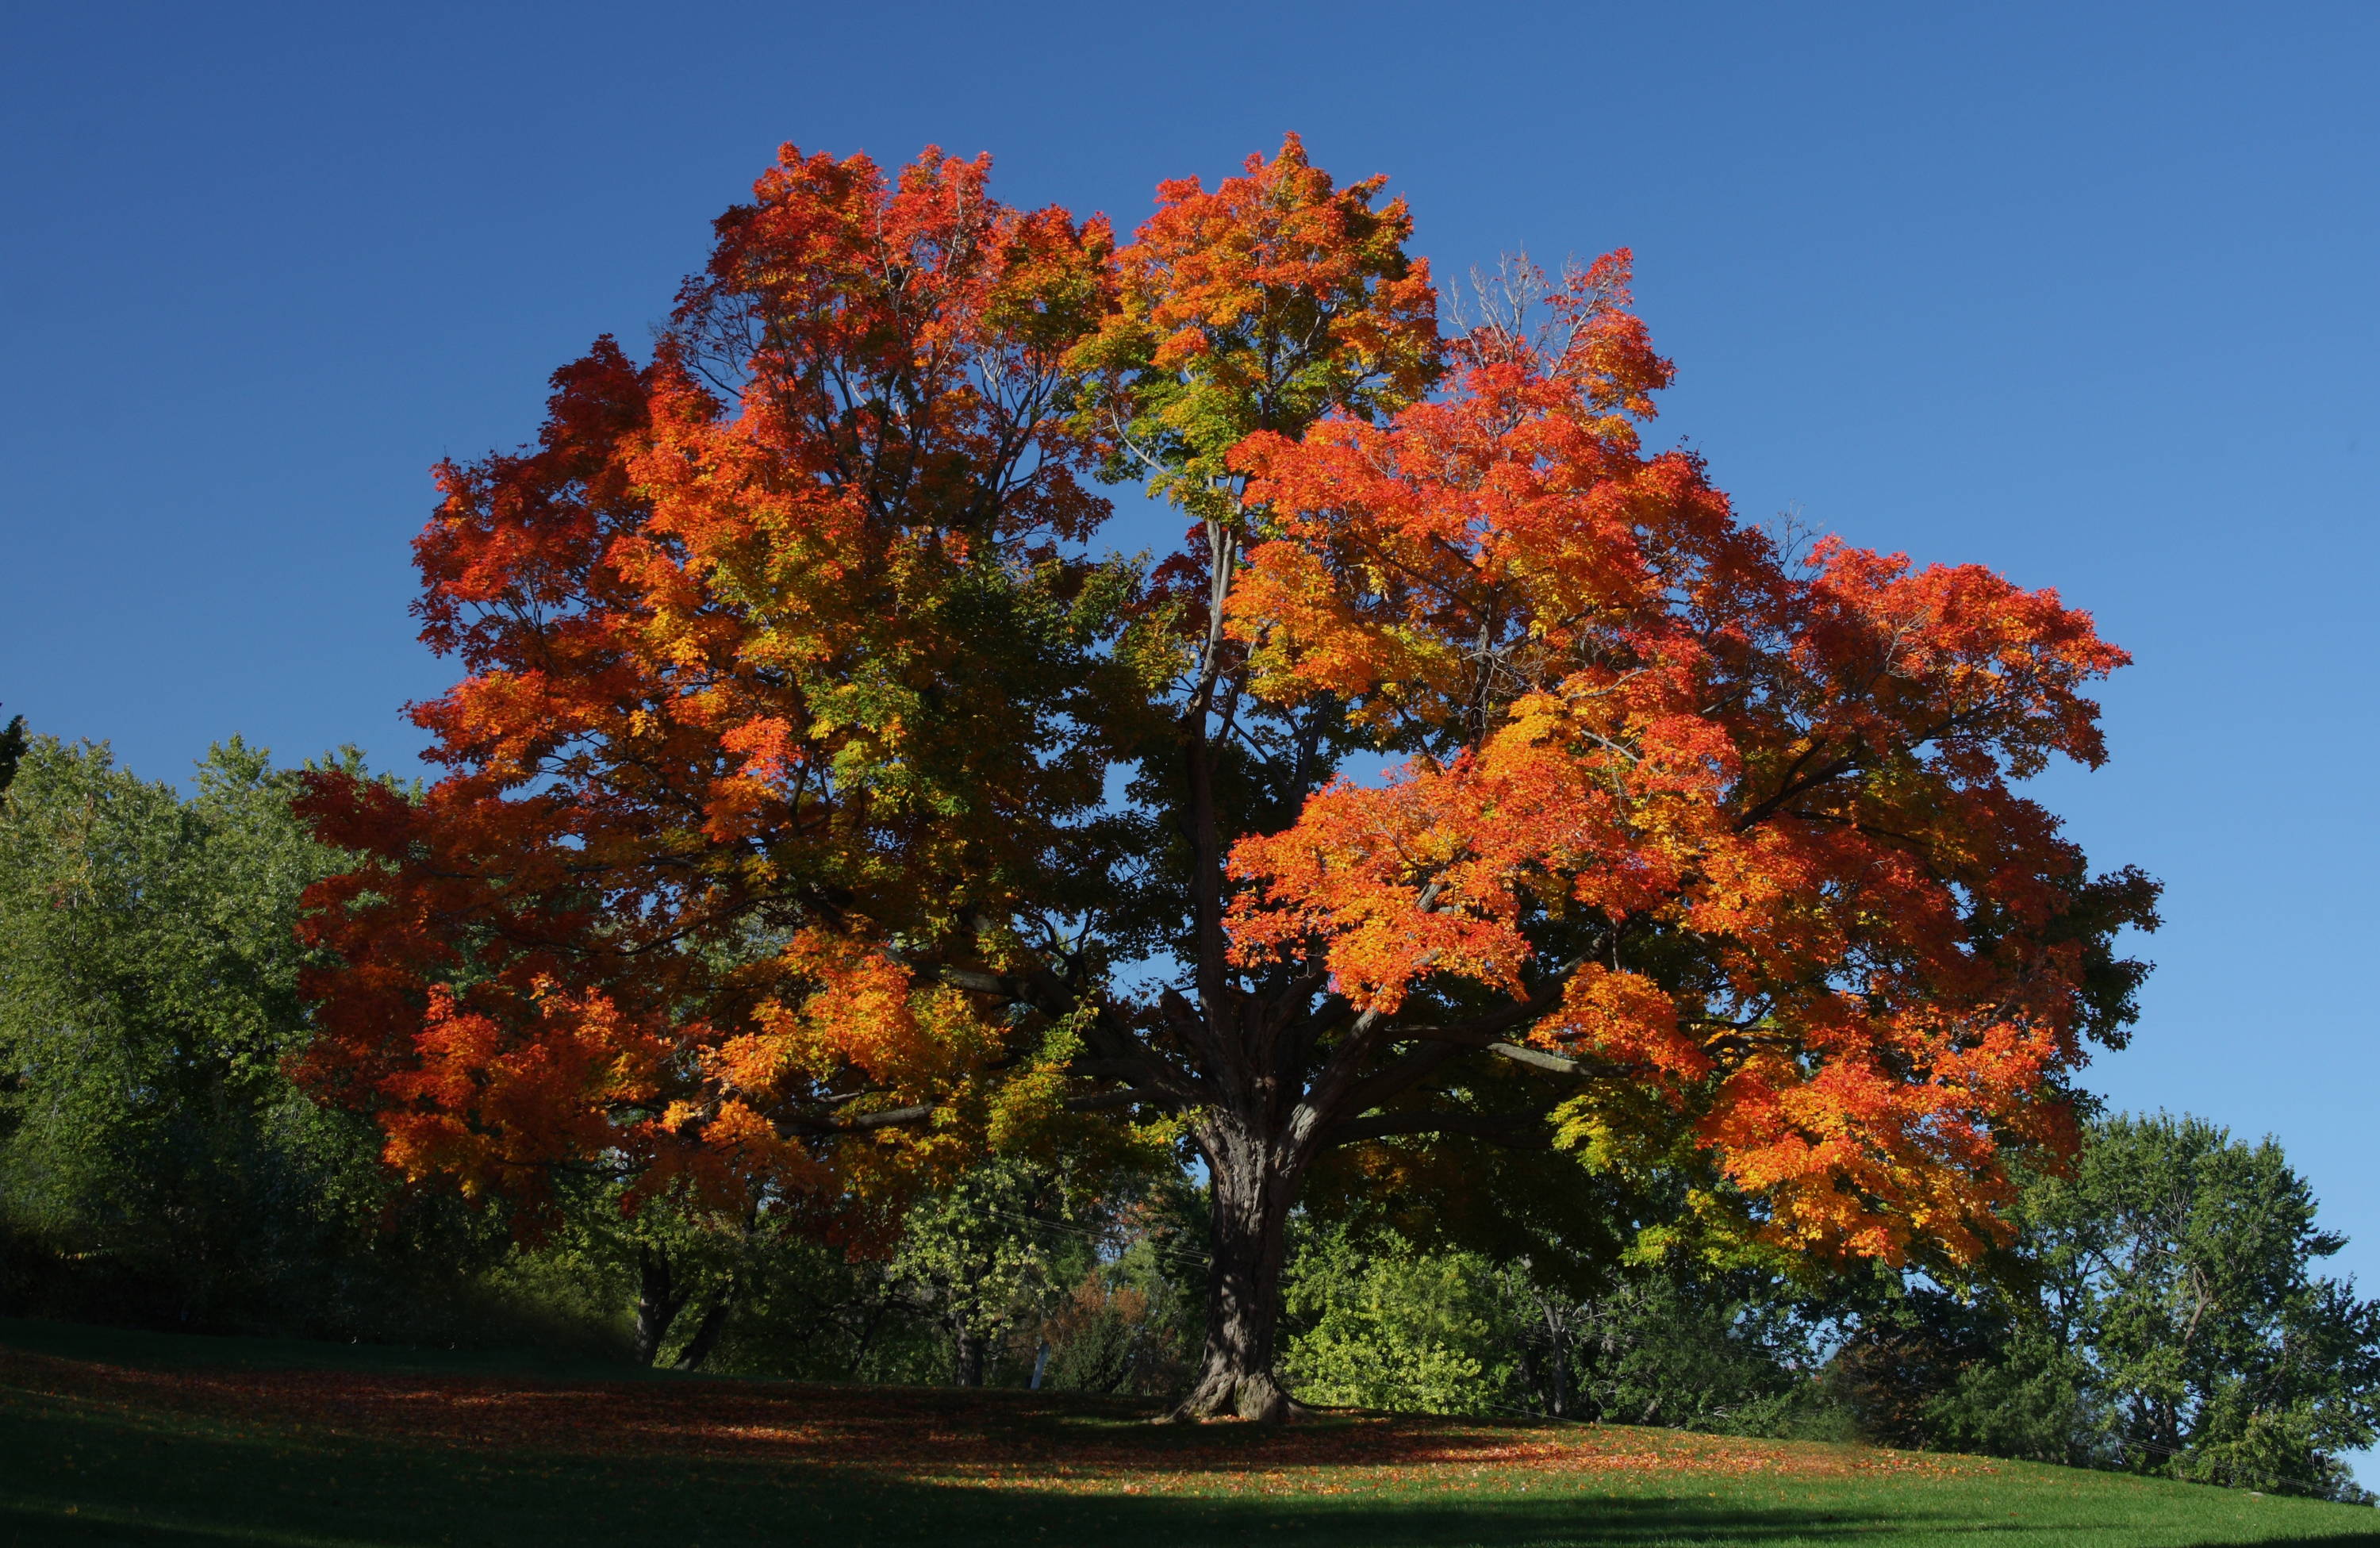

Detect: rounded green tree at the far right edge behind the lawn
[1933, 1115, 2380, 1496]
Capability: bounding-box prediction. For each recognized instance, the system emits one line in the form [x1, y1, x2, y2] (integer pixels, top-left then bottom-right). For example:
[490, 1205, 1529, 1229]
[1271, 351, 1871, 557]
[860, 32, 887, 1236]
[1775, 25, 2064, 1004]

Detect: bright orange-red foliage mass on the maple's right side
[1228, 252, 2152, 1260]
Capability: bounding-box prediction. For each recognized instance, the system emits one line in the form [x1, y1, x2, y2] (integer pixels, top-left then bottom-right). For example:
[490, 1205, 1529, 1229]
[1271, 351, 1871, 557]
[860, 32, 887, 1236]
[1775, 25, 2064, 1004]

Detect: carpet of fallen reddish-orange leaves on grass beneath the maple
[0, 1350, 1992, 1493]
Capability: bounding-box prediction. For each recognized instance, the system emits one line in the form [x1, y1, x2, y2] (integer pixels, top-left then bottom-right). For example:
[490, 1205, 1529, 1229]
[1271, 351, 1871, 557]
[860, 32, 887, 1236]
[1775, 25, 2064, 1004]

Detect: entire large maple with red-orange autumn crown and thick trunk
[305, 138, 2154, 1417]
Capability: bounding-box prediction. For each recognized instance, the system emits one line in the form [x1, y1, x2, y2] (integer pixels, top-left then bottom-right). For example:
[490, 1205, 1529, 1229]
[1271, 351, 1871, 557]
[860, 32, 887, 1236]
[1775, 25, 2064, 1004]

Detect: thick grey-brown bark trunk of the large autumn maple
[1173, 1122, 1304, 1424]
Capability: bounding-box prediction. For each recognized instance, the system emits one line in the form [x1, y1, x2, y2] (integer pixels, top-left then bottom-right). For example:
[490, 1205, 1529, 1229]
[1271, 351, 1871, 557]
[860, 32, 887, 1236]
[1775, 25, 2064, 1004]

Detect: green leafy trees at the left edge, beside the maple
[0, 738, 502, 1339]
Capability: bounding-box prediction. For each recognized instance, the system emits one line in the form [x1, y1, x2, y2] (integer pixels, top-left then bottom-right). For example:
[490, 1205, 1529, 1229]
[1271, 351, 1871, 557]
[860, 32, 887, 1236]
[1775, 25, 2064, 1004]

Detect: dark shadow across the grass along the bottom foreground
[0, 1403, 2380, 1548]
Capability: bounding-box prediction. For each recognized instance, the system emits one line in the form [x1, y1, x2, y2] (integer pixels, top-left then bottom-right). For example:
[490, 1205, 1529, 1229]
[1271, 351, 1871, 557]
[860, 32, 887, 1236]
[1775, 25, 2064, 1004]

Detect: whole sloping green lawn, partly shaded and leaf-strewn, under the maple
[0, 1322, 2380, 1548]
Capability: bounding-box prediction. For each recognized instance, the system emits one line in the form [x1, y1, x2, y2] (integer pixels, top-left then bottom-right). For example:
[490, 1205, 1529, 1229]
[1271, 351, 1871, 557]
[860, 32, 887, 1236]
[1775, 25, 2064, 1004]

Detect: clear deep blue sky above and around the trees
[0, 0, 2380, 1333]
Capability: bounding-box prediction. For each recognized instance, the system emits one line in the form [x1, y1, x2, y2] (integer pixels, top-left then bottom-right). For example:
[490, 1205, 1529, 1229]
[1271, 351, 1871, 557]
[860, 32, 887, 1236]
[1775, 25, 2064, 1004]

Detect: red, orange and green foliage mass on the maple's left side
[302, 148, 1109, 1205]
